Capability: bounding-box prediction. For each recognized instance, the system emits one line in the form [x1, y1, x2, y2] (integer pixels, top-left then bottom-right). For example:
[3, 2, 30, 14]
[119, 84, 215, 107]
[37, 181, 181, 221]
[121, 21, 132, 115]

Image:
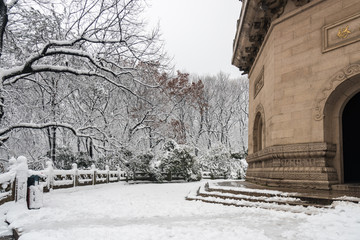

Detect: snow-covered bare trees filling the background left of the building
[0, 0, 248, 172]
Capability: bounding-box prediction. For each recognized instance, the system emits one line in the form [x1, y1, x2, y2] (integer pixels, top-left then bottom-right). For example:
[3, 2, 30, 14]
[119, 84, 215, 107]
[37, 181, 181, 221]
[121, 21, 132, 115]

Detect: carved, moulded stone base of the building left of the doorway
[247, 142, 339, 189]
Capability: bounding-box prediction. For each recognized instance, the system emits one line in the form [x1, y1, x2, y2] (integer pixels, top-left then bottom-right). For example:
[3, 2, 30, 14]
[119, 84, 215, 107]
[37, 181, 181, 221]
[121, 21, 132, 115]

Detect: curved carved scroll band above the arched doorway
[313, 63, 360, 121]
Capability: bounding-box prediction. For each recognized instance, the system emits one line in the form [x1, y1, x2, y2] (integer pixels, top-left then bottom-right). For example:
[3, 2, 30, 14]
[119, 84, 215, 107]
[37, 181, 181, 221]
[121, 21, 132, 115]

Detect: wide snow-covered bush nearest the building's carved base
[201, 145, 247, 179]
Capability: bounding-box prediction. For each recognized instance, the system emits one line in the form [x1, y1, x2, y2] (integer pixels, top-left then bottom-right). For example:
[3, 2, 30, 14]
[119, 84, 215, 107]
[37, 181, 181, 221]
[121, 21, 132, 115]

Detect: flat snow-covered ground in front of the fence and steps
[0, 182, 360, 240]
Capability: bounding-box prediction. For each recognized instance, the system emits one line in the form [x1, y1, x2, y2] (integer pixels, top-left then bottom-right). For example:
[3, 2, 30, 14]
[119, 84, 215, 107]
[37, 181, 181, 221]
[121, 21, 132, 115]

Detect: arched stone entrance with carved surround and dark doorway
[320, 64, 360, 184]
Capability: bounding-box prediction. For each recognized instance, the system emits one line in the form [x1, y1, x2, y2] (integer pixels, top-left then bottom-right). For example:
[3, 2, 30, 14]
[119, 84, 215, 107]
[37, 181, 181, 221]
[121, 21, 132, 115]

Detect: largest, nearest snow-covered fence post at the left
[15, 156, 28, 201]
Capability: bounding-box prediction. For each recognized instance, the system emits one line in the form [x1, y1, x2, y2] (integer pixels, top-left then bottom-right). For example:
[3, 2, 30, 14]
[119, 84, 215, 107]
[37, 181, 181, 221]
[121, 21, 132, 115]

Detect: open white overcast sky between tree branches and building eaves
[146, 0, 241, 78]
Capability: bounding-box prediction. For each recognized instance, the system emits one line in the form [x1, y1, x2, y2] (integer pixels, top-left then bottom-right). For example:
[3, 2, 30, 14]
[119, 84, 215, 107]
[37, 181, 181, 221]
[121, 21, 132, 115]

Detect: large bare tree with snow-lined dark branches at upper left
[0, 0, 164, 144]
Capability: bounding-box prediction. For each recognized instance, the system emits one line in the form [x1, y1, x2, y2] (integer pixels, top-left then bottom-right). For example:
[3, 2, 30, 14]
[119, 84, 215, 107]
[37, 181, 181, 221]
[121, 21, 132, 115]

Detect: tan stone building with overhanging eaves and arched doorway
[232, 0, 360, 189]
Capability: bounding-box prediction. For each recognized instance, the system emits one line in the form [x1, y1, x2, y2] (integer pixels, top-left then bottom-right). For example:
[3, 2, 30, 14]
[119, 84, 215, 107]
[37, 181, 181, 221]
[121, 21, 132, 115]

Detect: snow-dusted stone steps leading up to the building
[186, 182, 360, 214]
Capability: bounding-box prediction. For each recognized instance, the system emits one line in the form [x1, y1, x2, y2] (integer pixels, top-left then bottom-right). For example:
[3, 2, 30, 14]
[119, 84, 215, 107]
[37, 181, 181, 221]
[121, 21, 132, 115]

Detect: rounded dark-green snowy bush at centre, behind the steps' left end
[160, 140, 201, 181]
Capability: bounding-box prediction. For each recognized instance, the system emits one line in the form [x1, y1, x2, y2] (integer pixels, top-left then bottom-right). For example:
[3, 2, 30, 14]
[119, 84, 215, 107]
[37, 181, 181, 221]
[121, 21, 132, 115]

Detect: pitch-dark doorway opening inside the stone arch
[342, 93, 360, 183]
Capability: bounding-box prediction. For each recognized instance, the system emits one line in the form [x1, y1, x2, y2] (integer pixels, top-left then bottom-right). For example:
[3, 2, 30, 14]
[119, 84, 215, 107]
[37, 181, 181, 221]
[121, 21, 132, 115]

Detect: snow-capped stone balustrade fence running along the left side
[0, 157, 127, 205]
